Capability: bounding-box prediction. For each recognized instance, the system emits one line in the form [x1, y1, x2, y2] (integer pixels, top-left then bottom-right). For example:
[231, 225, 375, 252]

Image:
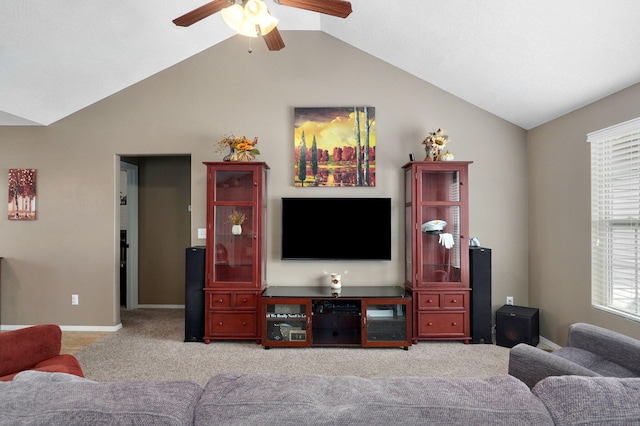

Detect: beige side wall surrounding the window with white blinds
[527, 84, 640, 345]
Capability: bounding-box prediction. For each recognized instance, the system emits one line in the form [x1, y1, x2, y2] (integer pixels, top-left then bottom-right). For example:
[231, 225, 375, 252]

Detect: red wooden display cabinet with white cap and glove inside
[403, 161, 471, 343]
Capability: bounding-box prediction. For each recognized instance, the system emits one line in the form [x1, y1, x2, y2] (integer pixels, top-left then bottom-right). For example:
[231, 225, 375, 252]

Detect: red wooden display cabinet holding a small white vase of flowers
[203, 162, 269, 343]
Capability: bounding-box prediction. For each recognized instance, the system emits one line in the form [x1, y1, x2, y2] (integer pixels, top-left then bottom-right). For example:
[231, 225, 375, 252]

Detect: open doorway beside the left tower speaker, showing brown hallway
[117, 155, 191, 309]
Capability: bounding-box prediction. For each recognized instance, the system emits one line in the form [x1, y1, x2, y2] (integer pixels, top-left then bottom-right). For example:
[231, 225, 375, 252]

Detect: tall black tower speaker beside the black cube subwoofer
[469, 247, 493, 344]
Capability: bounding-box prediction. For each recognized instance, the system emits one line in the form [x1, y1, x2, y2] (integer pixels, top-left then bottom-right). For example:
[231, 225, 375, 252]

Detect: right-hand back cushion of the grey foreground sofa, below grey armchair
[532, 376, 640, 426]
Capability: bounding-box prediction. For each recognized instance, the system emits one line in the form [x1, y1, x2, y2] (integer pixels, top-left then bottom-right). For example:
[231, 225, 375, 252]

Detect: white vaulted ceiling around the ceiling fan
[0, 0, 640, 129]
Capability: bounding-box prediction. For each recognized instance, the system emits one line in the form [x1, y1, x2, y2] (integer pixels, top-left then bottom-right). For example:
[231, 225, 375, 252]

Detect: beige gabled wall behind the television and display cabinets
[0, 32, 528, 326]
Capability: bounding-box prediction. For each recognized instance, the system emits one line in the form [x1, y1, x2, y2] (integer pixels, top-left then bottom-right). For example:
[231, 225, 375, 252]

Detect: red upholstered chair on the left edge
[0, 324, 84, 381]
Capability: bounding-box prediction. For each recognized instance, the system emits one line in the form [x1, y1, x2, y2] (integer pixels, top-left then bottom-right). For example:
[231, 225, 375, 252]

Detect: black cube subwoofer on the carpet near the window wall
[496, 305, 540, 348]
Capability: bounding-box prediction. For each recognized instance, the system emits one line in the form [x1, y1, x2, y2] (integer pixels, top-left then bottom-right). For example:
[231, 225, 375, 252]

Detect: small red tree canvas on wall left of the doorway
[8, 169, 36, 220]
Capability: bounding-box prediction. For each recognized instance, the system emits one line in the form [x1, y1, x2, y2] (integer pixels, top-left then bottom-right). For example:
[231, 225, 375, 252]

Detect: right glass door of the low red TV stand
[363, 299, 411, 347]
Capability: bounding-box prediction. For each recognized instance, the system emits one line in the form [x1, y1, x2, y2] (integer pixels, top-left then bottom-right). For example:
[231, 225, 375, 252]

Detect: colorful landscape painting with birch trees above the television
[294, 107, 376, 187]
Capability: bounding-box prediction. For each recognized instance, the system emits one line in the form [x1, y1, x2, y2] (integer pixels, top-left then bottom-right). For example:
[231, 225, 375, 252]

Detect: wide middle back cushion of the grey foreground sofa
[195, 373, 553, 425]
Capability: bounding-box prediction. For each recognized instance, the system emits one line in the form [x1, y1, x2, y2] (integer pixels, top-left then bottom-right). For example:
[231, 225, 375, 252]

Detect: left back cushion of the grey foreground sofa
[0, 381, 202, 426]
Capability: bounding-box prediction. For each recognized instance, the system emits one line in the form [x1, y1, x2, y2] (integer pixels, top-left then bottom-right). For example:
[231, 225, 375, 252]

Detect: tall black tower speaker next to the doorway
[184, 246, 205, 342]
